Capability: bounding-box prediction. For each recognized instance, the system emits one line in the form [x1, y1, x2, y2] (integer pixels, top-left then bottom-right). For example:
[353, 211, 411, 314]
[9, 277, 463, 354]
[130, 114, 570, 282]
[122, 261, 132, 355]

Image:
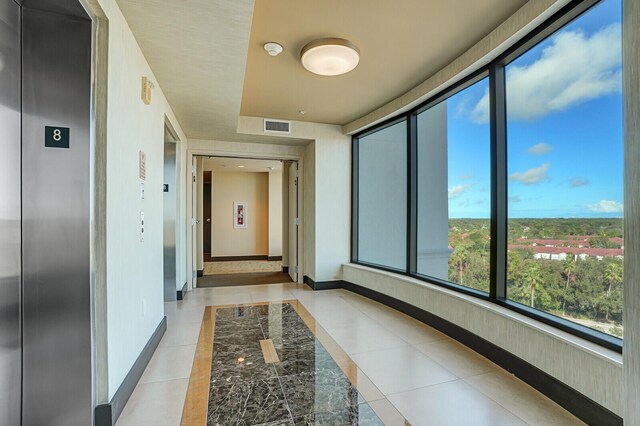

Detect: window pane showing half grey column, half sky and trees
[417, 78, 491, 293]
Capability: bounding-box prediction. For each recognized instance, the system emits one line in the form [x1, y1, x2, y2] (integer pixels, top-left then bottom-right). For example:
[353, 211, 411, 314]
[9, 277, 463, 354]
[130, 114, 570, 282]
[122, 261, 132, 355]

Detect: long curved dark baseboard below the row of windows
[342, 277, 622, 425]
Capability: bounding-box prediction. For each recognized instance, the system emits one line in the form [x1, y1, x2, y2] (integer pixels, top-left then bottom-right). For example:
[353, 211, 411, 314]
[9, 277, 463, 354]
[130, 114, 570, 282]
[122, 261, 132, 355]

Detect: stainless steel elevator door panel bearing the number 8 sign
[22, 6, 93, 426]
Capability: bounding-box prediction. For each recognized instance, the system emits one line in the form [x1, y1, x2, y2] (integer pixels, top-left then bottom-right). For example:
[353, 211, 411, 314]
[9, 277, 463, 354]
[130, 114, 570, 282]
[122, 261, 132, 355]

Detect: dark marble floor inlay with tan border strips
[182, 301, 384, 426]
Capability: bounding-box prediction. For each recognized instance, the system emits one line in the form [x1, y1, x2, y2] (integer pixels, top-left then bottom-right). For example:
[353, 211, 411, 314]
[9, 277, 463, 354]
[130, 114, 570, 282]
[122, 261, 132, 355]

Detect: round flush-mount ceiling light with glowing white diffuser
[300, 38, 360, 76]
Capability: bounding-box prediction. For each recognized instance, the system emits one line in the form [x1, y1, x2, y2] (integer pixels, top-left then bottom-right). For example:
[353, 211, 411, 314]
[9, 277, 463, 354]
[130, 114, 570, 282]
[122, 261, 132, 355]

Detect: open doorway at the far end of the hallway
[193, 156, 299, 287]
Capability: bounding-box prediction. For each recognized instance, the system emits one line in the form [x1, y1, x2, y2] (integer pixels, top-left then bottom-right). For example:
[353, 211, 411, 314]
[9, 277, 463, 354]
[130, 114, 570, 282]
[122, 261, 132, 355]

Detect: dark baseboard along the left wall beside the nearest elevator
[94, 317, 167, 426]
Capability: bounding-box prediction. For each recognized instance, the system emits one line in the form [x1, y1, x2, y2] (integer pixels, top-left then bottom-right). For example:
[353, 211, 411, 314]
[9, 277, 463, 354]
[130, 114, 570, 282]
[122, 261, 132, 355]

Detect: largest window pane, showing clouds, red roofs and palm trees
[505, 0, 624, 337]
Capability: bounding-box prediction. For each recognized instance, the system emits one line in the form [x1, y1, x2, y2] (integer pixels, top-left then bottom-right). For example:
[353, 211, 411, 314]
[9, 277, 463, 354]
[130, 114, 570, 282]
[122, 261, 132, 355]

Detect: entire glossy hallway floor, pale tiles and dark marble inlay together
[117, 283, 583, 426]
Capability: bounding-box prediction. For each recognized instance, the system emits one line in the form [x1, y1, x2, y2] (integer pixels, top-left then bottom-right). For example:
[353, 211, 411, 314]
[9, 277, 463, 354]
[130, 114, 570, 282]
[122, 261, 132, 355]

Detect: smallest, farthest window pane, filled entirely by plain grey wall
[358, 120, 407, 270]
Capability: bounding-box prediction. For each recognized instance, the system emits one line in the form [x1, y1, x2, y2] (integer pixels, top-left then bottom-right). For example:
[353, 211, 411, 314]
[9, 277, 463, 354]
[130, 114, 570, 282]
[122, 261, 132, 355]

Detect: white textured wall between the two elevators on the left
[91, 0, 186, 402]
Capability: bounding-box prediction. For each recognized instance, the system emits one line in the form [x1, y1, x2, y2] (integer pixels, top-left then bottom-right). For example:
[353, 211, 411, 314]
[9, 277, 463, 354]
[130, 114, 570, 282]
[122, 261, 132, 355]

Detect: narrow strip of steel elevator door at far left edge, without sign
[0, 0, 22, 426]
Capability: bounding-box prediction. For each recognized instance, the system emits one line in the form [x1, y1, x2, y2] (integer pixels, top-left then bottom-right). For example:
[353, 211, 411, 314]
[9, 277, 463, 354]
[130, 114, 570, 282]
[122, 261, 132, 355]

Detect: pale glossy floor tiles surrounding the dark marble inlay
[117, 283, 583, 426]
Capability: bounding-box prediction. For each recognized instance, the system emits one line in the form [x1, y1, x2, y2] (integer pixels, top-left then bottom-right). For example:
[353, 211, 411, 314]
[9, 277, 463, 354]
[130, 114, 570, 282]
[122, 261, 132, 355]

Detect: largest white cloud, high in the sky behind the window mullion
[471, 23, 622, 123]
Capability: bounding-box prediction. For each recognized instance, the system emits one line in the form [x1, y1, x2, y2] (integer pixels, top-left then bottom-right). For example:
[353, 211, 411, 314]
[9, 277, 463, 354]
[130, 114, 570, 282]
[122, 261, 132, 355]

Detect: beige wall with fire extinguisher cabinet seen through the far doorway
[211, 172, 269, 257]
